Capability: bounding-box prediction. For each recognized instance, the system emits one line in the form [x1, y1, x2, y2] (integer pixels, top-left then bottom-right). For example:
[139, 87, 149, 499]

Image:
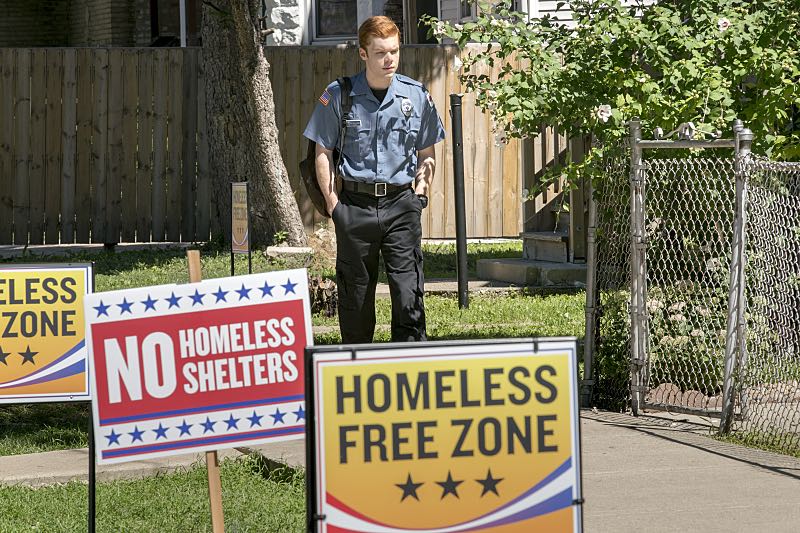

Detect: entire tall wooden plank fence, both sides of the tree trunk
[0, 46, 566, 244]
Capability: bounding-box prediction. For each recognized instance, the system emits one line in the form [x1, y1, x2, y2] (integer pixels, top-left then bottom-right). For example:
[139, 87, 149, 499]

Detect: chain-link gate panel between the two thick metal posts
[642, 156, 735, 412]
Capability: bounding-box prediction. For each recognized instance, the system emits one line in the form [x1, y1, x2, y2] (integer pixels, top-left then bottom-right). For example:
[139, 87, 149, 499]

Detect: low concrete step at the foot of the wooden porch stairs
[478, 259, 586, 288]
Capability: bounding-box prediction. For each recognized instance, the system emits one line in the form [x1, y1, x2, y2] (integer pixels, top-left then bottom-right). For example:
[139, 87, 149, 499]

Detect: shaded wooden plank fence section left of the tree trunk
[0, 48, 210, 244]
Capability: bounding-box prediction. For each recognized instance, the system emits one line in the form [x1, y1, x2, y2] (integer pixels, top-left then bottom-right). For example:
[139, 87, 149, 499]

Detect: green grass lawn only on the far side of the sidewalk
[0, 241, 584, 455]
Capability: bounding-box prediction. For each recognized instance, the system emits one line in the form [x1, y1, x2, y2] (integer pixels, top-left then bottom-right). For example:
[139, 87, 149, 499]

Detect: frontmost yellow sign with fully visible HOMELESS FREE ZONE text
[313, 340, 581, 533]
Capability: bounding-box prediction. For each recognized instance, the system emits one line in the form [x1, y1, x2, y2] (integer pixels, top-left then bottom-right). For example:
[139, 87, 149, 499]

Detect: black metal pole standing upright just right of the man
[450, 94, 469, 309]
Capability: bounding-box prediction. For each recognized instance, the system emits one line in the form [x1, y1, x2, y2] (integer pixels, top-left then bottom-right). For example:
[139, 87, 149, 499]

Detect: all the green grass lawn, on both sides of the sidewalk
[0, 243, 585, 533]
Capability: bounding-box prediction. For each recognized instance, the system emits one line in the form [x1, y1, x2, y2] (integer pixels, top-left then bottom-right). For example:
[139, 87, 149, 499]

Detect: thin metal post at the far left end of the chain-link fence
[580, 179, 598, 407]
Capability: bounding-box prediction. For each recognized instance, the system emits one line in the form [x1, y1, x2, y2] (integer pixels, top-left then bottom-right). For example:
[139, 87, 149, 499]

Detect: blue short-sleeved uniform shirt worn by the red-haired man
[303, 71, 445, 185]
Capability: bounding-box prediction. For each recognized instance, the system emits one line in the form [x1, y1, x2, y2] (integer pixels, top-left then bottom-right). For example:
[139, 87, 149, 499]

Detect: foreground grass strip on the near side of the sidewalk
[0, 457, 305, 533]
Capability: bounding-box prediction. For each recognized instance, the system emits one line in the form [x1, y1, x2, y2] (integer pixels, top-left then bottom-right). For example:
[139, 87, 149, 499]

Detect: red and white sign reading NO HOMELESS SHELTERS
[85, 269, 313, 464]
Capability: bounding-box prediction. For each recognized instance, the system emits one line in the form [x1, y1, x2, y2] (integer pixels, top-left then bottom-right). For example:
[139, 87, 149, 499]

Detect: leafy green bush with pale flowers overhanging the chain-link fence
[428, 0, 800, 194]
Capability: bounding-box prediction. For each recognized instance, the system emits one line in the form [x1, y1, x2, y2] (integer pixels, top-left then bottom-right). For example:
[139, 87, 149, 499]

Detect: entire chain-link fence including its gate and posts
[585, 123, 800, 452]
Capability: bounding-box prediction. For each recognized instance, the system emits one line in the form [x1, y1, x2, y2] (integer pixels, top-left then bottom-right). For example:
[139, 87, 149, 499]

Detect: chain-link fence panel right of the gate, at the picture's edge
[733, 157, 800, 452]
